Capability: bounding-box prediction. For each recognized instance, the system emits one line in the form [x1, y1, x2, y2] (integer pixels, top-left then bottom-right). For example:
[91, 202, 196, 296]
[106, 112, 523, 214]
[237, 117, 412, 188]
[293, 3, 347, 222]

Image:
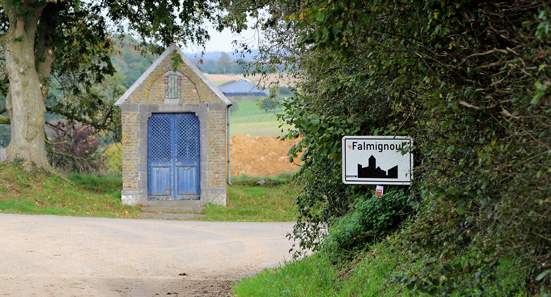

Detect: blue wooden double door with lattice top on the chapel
[147, 113, 201, 200]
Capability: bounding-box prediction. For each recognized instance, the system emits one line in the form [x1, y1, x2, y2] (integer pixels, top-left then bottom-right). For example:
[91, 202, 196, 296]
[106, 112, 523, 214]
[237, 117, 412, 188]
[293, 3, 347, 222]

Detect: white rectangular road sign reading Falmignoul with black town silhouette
[342, 136, 413, 185]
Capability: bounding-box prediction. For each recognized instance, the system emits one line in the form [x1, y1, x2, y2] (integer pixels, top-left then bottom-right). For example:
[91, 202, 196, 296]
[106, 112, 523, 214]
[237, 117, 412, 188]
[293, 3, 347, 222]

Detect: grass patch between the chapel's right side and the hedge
[202, 175, 299, 222]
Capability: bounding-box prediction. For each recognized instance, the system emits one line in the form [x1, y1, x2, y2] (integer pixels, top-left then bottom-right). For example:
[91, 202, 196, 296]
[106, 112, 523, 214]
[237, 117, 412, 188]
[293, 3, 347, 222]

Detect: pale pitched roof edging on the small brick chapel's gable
[115, 44, 232, 106]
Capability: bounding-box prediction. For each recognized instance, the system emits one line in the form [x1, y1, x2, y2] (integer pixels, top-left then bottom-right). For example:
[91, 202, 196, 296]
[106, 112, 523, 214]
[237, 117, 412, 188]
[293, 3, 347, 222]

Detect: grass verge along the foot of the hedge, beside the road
[232, 228, 536, 297]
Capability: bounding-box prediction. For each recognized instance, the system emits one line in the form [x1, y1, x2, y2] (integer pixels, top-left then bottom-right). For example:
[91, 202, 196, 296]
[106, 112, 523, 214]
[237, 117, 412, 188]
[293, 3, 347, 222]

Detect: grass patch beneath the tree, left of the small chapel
[0, 163, 140, 218]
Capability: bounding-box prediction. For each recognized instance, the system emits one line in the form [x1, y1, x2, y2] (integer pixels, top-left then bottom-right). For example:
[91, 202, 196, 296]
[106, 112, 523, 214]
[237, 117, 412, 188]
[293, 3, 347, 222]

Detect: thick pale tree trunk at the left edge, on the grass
[3, 1, 50, 169]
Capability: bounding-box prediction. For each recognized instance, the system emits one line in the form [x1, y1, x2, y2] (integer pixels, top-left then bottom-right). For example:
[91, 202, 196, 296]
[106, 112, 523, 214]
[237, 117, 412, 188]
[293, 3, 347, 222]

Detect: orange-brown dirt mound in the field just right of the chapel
[230, 134, 300, 176]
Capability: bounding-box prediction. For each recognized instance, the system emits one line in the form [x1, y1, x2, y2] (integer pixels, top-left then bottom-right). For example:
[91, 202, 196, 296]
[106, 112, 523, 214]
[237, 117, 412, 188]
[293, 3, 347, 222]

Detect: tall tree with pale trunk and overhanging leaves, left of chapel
[0, 0, 224, 168]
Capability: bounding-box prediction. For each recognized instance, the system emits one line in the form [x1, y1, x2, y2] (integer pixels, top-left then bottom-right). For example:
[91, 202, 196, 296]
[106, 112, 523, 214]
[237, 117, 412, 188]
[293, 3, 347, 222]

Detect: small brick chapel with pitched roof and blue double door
[115, 45, 231, 207]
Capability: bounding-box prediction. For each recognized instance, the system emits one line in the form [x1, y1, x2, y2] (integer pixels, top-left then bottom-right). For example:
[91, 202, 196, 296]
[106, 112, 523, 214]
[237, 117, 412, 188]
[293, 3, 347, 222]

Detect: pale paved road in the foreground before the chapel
[0, 214, 292, 296]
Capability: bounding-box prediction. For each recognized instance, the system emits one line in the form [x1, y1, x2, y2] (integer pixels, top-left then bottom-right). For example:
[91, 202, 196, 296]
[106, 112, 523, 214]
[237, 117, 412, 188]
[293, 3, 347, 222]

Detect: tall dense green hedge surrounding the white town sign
[223, 0, 551, 296]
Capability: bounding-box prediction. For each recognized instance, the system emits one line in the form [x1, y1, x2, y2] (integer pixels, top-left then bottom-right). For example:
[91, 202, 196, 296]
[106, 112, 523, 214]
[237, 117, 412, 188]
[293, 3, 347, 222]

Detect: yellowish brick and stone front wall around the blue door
[120, 48, 227, 205]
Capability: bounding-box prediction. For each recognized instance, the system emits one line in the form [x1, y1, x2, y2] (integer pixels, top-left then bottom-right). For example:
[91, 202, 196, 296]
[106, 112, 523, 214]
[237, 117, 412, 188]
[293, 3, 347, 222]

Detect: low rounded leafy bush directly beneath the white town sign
[322, 190, 410, 260]
